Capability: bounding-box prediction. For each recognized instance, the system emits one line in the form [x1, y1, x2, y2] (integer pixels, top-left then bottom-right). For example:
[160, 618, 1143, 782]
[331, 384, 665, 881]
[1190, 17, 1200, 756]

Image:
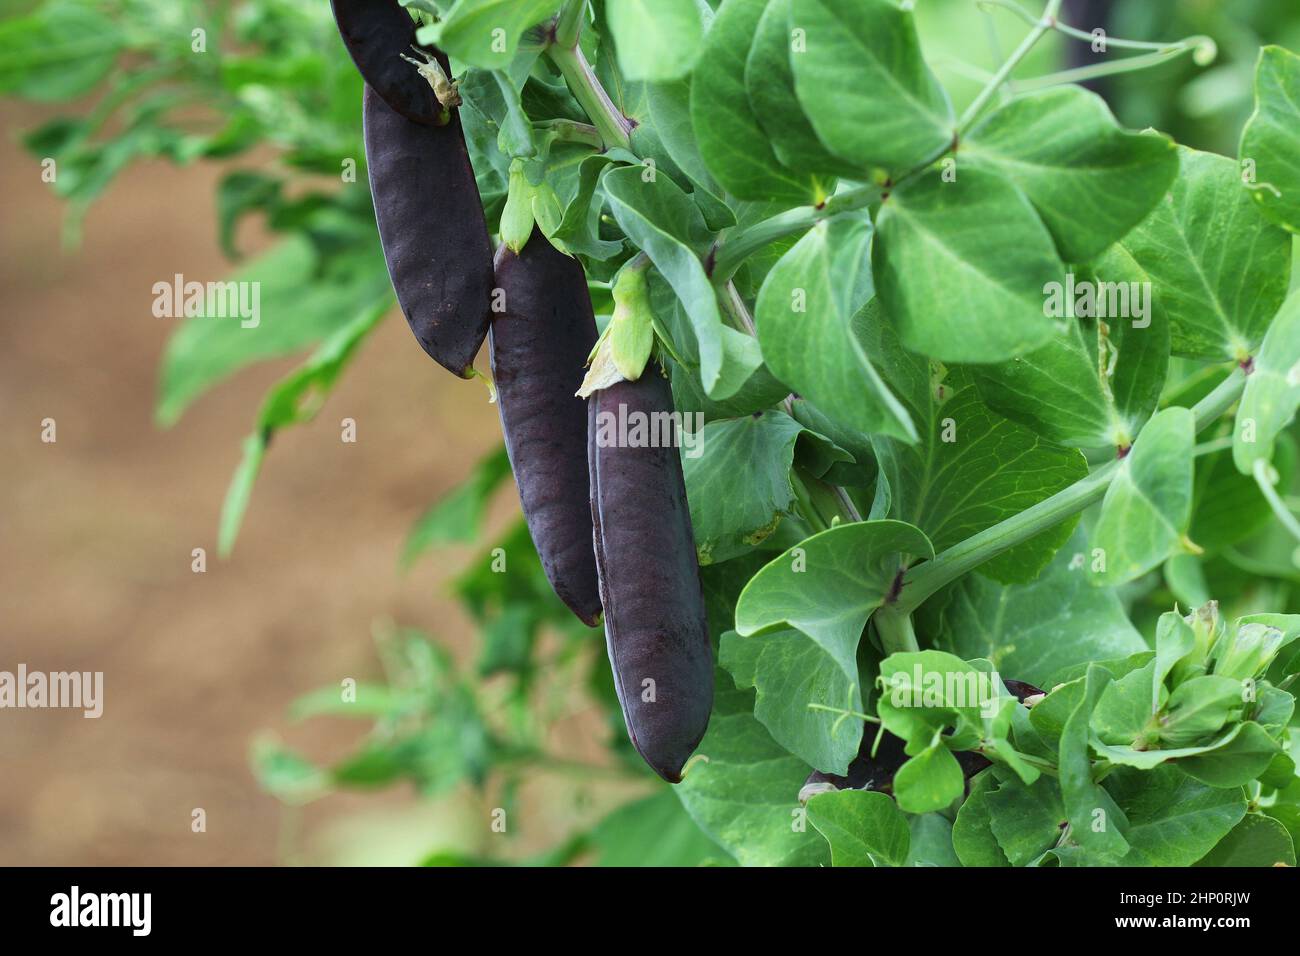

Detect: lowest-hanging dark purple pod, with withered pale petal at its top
[588, 363, 714, 783]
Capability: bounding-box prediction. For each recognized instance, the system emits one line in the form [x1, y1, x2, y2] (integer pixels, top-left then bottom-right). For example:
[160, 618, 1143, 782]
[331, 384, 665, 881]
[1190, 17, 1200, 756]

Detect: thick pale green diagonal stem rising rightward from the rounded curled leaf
[894, 371, 1245, 615]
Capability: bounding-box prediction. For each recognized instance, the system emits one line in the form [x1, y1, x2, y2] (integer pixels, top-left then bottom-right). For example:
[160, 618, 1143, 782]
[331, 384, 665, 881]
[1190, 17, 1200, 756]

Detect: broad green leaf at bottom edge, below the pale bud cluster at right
[1106, 766, 1245, 866]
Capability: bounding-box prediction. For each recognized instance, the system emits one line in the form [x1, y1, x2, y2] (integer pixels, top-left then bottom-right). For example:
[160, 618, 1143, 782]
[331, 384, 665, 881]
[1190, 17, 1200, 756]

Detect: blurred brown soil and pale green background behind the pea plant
[0, 0, 1300, 865]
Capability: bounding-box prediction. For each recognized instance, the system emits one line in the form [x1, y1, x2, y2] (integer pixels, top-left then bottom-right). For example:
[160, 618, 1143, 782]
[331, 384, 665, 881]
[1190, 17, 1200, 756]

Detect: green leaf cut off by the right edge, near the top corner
[1242, 47, 1300, 233]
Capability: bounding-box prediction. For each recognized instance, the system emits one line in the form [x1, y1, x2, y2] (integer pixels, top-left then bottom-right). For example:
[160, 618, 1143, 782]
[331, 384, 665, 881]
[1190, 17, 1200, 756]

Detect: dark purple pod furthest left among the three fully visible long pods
[364, 85, 493, 377]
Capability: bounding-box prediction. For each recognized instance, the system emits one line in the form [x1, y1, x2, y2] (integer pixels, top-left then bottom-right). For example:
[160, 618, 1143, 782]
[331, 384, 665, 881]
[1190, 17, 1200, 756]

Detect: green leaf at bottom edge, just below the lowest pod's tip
[673, 675, 831, 866]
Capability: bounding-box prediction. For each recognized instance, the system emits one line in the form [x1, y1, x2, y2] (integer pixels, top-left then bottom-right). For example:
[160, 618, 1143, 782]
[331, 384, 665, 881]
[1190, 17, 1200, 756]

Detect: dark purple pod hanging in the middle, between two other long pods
[488, 228, 601, 626]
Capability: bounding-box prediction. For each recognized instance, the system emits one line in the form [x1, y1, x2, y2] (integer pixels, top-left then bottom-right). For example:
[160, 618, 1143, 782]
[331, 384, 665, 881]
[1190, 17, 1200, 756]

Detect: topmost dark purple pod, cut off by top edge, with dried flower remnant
[330, 0, 441, 125]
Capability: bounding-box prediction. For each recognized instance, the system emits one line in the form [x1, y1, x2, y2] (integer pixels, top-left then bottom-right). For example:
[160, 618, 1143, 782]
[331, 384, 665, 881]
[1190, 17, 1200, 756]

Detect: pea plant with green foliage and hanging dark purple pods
[0, 0, 1300, 866]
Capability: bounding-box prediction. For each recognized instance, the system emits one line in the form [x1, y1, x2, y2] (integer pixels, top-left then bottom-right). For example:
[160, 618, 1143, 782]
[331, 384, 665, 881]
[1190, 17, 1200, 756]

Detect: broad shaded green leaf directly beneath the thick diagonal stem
[918, 532, 1147, 687]
